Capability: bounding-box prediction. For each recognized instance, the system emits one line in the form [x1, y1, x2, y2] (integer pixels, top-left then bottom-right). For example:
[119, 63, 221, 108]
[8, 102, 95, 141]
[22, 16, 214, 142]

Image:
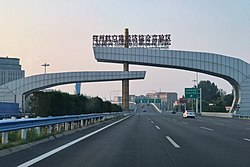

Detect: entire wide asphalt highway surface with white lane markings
[0, 105, 250, 167]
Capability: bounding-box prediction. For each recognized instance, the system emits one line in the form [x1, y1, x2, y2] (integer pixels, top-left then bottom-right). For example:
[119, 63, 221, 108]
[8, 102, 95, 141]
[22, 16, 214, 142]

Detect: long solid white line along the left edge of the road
[18, 115, 131, 167]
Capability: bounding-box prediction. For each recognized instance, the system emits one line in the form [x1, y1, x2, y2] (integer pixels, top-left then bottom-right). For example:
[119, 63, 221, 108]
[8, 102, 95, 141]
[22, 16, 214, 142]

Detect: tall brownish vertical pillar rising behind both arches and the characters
[122, 28, 129, 110]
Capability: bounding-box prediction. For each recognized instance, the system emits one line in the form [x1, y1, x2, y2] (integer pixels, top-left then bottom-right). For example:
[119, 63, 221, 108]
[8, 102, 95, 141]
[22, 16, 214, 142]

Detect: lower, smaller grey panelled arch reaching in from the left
[0, 71, 146, 111]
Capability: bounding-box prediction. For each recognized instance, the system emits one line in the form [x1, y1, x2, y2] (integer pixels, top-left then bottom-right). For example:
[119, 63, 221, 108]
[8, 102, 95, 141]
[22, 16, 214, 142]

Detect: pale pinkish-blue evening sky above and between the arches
[0, 0, 250, 100]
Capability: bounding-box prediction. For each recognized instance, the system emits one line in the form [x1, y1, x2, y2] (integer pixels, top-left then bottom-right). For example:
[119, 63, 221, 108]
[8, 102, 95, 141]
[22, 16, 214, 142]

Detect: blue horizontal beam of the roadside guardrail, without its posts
[0, 112, 128, 132]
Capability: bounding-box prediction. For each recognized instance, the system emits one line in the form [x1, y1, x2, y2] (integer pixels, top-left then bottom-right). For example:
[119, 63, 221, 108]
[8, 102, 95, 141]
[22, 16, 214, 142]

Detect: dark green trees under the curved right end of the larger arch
[189, 80, 233, 112]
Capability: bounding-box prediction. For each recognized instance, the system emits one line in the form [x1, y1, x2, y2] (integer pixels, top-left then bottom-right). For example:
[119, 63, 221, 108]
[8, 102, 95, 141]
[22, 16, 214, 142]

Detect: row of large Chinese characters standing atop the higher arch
[93, 34, 171, 48]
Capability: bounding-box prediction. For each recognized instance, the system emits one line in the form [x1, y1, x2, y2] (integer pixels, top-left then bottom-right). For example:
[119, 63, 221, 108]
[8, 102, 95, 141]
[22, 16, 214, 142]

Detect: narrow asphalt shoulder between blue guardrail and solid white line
[0, 119, 129, 167]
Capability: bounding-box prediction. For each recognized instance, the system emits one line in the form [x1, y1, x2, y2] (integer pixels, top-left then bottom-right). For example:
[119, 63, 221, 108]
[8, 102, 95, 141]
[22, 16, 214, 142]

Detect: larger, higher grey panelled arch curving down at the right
[93, 46, 250, 115]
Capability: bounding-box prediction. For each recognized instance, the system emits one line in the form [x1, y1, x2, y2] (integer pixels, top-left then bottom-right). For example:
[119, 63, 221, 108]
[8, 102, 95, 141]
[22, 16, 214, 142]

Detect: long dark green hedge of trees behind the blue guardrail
[27, 91, 122, 116]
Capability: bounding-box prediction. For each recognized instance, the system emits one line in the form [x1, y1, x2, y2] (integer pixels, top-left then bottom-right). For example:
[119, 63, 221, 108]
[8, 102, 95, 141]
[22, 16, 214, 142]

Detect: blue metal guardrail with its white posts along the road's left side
[0, 112, 130, 144]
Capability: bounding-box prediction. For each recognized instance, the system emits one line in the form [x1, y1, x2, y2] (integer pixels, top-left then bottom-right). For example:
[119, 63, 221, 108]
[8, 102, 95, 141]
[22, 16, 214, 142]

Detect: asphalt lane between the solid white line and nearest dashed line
[30, 113, 175, 167]
